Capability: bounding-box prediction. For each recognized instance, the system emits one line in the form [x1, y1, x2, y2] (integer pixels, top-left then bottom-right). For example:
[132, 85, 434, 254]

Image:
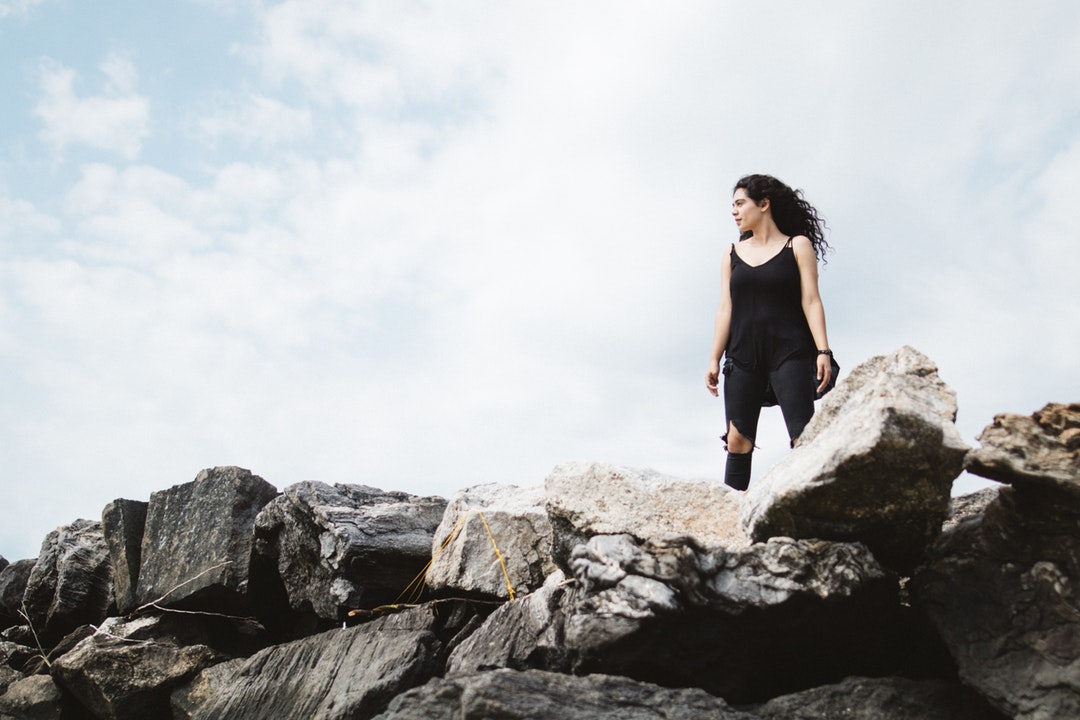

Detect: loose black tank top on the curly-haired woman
[727, 239, 816, 372]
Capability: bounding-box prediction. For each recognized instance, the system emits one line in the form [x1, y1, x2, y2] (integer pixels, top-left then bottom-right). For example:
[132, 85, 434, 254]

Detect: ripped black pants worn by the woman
[724, 357, 818, 490]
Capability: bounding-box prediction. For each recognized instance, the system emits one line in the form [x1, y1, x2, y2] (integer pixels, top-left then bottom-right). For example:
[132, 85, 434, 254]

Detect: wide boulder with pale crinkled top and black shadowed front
[565, 535, 902, 703]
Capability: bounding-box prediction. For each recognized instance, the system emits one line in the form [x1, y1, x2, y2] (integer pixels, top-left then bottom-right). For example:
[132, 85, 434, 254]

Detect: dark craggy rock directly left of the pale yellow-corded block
[255, 483, 446, 623]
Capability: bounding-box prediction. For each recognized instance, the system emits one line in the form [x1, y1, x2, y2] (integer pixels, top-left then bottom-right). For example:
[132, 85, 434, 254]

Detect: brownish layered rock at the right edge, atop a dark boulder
[964, 403, 1080, 500]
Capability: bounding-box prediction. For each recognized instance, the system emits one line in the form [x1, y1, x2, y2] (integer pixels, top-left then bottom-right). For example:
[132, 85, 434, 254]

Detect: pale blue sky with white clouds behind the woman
[0, 0, 1080, 559]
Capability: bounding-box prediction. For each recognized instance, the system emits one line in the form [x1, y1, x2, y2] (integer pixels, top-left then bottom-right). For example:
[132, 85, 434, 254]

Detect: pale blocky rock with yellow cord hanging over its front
[427, 484, 555, 599]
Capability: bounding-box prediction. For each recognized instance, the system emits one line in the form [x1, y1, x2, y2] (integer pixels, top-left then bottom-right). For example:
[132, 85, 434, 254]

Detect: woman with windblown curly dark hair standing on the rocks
[705, 175, 833, 490]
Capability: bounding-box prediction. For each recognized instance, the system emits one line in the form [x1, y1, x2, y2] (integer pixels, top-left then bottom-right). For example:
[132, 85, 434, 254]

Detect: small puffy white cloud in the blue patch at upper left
[33, 54, 150, 160]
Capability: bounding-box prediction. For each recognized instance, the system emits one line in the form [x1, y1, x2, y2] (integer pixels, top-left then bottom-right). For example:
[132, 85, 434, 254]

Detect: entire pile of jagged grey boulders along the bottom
[0, 349, 1080, 720]
